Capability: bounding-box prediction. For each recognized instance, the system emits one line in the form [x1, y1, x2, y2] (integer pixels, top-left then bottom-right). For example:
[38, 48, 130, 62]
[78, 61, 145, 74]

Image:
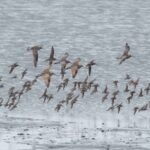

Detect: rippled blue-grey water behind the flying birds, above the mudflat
[0, 0, 150, 149]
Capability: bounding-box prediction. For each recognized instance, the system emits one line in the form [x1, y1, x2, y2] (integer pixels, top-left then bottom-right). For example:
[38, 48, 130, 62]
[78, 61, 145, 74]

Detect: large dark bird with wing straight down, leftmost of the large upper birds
[27, 46, 42, 67]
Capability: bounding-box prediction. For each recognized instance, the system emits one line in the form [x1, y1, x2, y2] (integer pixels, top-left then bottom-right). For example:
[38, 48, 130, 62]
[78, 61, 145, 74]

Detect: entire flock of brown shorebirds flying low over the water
[0, 43, 150, 115]
